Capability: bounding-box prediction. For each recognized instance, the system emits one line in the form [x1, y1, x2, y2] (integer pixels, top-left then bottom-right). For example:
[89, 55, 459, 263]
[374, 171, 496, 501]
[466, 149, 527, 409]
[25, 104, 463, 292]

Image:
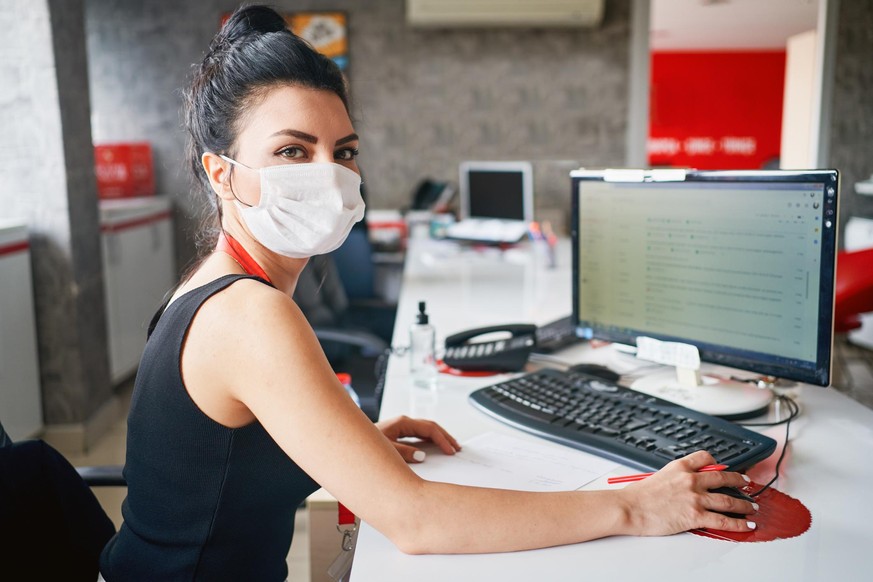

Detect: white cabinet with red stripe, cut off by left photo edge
[0, 222, 43, 440]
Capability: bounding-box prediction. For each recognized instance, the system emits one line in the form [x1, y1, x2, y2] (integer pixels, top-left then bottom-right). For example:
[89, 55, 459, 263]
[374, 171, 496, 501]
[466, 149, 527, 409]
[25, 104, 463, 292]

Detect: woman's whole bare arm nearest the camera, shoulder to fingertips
[182, 281, 752, 553]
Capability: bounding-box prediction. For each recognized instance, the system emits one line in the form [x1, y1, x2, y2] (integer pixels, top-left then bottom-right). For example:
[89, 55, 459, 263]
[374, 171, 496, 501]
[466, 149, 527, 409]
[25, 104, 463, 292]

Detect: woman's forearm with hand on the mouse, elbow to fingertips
[330, 451, 754, 554]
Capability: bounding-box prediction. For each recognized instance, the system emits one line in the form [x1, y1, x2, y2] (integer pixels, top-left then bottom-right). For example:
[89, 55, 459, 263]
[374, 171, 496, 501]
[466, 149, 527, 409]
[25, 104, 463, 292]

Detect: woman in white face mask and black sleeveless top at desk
[101, 6, 753, 582]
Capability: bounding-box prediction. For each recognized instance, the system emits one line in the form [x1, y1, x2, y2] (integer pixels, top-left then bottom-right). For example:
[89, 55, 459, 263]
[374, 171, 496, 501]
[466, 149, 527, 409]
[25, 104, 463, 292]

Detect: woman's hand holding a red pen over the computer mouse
[622, 451, 757, 535]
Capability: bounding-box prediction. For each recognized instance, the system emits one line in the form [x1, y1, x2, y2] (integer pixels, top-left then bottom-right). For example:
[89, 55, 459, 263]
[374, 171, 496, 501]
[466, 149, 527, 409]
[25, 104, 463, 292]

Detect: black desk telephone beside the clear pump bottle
[443, 323, 537, 372]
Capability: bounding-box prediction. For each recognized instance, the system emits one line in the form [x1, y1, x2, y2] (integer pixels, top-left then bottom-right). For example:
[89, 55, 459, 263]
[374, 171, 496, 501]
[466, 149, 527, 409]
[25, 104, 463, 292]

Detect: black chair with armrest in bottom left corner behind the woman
[0, 424, 125, 582]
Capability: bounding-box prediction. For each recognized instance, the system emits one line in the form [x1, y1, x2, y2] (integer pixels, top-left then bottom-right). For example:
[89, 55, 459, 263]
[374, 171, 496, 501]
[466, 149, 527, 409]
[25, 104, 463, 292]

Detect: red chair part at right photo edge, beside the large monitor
[834, 248, 873, 333]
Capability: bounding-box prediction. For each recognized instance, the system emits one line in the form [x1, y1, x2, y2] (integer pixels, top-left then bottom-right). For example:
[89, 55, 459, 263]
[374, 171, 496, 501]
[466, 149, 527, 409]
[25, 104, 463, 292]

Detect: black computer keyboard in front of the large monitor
[470, 370, 776, 471]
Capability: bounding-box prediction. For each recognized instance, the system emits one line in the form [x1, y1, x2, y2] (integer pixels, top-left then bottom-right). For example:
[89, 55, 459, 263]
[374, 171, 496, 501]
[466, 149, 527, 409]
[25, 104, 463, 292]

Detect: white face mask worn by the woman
[221, 156, 364, 259]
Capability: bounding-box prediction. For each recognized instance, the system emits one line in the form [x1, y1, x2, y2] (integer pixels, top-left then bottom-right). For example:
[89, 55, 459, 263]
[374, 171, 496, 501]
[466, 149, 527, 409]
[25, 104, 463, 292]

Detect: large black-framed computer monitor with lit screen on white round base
[571, 170, 839, 418]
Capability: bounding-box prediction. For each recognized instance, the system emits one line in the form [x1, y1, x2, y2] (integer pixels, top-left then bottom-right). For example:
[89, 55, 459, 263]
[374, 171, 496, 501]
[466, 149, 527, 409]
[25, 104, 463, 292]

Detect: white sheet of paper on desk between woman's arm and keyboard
[412, 433, 618, 491]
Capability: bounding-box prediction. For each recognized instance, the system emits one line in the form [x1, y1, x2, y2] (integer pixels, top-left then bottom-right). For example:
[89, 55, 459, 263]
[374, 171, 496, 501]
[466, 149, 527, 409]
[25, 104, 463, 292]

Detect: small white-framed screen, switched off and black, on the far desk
[459, 161, 534, 222]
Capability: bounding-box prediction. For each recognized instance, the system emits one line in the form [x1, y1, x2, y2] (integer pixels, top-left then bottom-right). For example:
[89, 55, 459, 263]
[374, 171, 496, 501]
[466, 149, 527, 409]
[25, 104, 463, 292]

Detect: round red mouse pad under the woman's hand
[691, 483, 812, 542]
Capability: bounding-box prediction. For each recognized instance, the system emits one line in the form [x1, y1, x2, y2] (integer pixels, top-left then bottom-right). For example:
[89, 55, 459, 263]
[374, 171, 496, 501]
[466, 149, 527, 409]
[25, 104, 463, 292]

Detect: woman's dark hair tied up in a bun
[184, 5, 349, 250]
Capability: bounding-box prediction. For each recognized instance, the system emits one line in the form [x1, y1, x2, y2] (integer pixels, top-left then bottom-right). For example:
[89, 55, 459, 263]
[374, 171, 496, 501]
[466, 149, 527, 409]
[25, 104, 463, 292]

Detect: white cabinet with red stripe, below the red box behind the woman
[100, 196, 176, 383]
